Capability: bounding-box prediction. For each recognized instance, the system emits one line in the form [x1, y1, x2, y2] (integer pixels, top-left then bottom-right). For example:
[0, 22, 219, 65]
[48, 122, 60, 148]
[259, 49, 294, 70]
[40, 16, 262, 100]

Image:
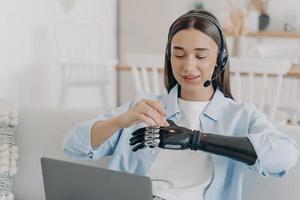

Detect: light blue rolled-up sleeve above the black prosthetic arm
[247, 105, 299, 177]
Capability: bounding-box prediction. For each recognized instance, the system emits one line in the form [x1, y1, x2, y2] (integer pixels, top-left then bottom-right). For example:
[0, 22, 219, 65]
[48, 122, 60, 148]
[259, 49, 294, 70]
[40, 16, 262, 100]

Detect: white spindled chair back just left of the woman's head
[125, 53, 164, 94]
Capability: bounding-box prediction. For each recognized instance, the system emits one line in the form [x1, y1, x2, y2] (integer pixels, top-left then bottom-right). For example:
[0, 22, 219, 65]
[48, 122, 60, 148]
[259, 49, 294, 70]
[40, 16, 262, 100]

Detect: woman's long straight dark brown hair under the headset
[164, 10, 233, 99]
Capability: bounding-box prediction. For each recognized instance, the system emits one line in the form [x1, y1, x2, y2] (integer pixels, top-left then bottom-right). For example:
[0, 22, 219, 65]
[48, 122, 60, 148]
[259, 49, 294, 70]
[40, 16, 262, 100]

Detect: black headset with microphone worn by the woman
[166, 13, 229, 87]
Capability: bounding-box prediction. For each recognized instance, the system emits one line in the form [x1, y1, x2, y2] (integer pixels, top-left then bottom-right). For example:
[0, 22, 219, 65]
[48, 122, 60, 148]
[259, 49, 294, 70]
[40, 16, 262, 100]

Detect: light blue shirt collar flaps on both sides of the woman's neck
[166, 84, 225, 121]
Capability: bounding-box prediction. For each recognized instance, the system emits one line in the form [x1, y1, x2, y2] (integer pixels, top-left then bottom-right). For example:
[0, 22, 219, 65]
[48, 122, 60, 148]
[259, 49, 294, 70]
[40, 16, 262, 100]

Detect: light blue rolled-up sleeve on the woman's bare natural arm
[63, 100, 133, 160]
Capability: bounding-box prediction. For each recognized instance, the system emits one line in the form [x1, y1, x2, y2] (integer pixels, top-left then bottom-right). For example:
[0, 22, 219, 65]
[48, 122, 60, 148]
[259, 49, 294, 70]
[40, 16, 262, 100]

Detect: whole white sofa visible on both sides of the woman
[13, 106, 300, 200]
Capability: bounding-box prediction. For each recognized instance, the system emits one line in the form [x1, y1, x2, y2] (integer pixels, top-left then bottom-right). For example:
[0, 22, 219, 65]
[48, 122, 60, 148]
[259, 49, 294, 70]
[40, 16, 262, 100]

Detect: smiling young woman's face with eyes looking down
[171, 29, 218, 91]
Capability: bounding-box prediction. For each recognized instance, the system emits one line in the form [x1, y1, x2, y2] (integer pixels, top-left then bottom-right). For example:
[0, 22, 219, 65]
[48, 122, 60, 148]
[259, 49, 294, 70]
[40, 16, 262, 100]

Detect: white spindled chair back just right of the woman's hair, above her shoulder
[230, 57, 292, 121]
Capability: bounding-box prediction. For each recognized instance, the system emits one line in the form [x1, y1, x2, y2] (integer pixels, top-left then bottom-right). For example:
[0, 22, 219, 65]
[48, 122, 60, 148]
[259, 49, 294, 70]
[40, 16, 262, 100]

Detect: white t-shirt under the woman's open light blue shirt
[147, 98, 213, 200]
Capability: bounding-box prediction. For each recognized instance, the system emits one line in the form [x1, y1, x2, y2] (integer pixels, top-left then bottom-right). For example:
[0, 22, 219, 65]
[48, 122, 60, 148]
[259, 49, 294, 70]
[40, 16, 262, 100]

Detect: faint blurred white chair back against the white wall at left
[54, 20, 103, 63]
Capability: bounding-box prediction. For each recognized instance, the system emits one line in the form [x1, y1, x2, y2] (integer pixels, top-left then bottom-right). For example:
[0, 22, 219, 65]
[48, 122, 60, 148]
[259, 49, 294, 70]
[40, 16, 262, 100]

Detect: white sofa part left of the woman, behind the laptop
[13, 106, 106, 200]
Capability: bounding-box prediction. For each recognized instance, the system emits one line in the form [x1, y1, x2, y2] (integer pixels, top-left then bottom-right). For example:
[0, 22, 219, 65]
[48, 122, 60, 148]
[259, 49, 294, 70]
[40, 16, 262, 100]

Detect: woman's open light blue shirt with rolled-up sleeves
[64, 85, 299, 200]
